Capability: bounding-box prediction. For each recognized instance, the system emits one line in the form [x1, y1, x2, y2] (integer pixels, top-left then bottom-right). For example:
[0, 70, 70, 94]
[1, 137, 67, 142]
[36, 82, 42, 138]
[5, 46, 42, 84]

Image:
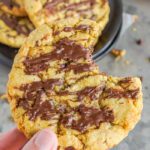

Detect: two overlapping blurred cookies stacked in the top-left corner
[0, 0, 34, 48]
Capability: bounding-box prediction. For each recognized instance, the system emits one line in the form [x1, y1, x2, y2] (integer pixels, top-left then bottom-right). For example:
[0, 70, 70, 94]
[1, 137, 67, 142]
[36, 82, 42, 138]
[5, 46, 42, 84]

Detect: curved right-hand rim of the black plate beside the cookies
[93, 0, 123, 60]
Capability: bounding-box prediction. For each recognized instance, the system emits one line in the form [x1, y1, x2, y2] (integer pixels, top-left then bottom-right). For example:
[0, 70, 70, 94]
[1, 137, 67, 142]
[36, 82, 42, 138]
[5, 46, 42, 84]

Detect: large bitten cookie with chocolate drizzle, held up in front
[7, 20, 142, 150]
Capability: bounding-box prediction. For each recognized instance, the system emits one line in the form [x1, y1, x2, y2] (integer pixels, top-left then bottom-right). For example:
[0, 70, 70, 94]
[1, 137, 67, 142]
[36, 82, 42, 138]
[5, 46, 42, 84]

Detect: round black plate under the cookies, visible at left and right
[0, 0, 123, 66]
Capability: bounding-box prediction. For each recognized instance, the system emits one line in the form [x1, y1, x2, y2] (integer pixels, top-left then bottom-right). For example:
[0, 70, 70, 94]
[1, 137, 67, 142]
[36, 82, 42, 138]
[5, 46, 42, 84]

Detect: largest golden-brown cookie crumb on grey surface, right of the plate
[111, 49, 126, 60]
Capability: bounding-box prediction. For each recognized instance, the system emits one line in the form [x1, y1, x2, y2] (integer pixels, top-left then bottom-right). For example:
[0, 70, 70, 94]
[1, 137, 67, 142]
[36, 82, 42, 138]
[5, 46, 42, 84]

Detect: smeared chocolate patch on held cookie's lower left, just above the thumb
[18, 79, 63, 121]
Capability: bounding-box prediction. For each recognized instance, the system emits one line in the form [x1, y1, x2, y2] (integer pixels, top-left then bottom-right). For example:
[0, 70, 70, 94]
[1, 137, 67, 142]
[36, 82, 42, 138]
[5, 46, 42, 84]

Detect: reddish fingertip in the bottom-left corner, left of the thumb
[0, 128, 27, 150]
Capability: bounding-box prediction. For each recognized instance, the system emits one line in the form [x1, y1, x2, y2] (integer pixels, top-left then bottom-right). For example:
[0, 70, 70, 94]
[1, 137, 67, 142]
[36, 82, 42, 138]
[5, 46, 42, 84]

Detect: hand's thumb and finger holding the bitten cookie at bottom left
[0, 128, 58, 150]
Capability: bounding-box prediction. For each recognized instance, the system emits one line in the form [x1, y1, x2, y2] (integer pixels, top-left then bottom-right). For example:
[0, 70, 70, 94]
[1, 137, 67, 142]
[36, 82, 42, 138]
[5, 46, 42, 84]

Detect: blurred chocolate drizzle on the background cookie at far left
[0, 13, 32, 36]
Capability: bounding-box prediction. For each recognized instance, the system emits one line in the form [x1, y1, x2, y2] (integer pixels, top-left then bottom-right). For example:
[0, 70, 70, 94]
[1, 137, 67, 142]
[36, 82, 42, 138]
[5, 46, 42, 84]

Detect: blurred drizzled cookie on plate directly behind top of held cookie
[25, 0, 110, 31]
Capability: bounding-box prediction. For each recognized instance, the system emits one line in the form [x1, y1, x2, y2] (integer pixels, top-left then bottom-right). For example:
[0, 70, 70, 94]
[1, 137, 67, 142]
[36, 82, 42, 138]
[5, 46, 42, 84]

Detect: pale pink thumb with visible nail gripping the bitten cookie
[22, 128, 58, 150]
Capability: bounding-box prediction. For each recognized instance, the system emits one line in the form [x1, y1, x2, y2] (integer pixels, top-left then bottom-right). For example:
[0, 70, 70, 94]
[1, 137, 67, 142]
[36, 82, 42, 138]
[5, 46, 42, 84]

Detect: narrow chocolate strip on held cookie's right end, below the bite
[105, 88, 139, 99]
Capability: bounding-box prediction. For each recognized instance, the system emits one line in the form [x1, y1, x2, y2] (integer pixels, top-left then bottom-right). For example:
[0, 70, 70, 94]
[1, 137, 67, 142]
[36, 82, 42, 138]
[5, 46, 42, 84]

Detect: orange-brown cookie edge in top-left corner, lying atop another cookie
[0, 0, 27, 17]
